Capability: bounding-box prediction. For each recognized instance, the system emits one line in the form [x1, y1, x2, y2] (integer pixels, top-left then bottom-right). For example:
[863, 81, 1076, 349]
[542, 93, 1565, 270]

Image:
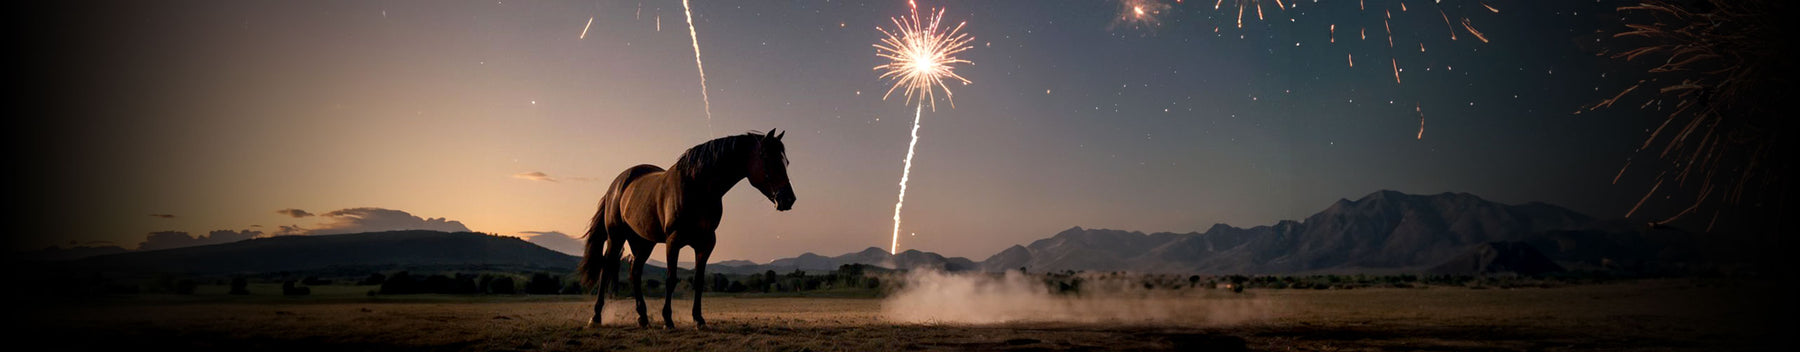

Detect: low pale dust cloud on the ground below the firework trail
[882, 269, 1276, 325]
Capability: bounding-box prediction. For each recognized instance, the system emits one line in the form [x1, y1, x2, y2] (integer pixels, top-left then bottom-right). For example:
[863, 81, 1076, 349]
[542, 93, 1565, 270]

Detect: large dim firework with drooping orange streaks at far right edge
[1584, 0, 1791, 232]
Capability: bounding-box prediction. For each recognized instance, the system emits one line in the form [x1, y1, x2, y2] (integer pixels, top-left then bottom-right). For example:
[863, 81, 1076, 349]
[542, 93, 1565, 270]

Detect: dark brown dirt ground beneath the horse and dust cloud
[24, 280, 1795, 352]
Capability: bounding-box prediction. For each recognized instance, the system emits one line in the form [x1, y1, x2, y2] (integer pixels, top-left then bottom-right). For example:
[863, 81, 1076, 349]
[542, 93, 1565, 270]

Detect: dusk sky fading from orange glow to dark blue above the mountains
[13, 0, 1661, 262]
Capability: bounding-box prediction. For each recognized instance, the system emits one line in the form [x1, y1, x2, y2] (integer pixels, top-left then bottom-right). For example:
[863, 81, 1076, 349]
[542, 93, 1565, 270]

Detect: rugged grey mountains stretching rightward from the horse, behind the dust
[720, 190, 1699, 275]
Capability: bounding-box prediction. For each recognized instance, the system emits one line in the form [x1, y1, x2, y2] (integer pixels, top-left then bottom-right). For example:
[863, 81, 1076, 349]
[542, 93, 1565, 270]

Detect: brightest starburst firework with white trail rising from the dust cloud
[875, 4, 976, 253]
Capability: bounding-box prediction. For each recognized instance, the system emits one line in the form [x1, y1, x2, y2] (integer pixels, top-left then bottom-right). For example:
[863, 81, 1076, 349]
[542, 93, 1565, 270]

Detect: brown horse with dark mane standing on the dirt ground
[578, 129, 794, 329]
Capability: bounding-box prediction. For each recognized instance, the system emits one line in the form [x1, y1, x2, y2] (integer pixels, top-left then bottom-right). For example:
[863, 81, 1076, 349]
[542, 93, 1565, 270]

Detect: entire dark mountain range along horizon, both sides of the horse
[24, 190, 1721, 275]
